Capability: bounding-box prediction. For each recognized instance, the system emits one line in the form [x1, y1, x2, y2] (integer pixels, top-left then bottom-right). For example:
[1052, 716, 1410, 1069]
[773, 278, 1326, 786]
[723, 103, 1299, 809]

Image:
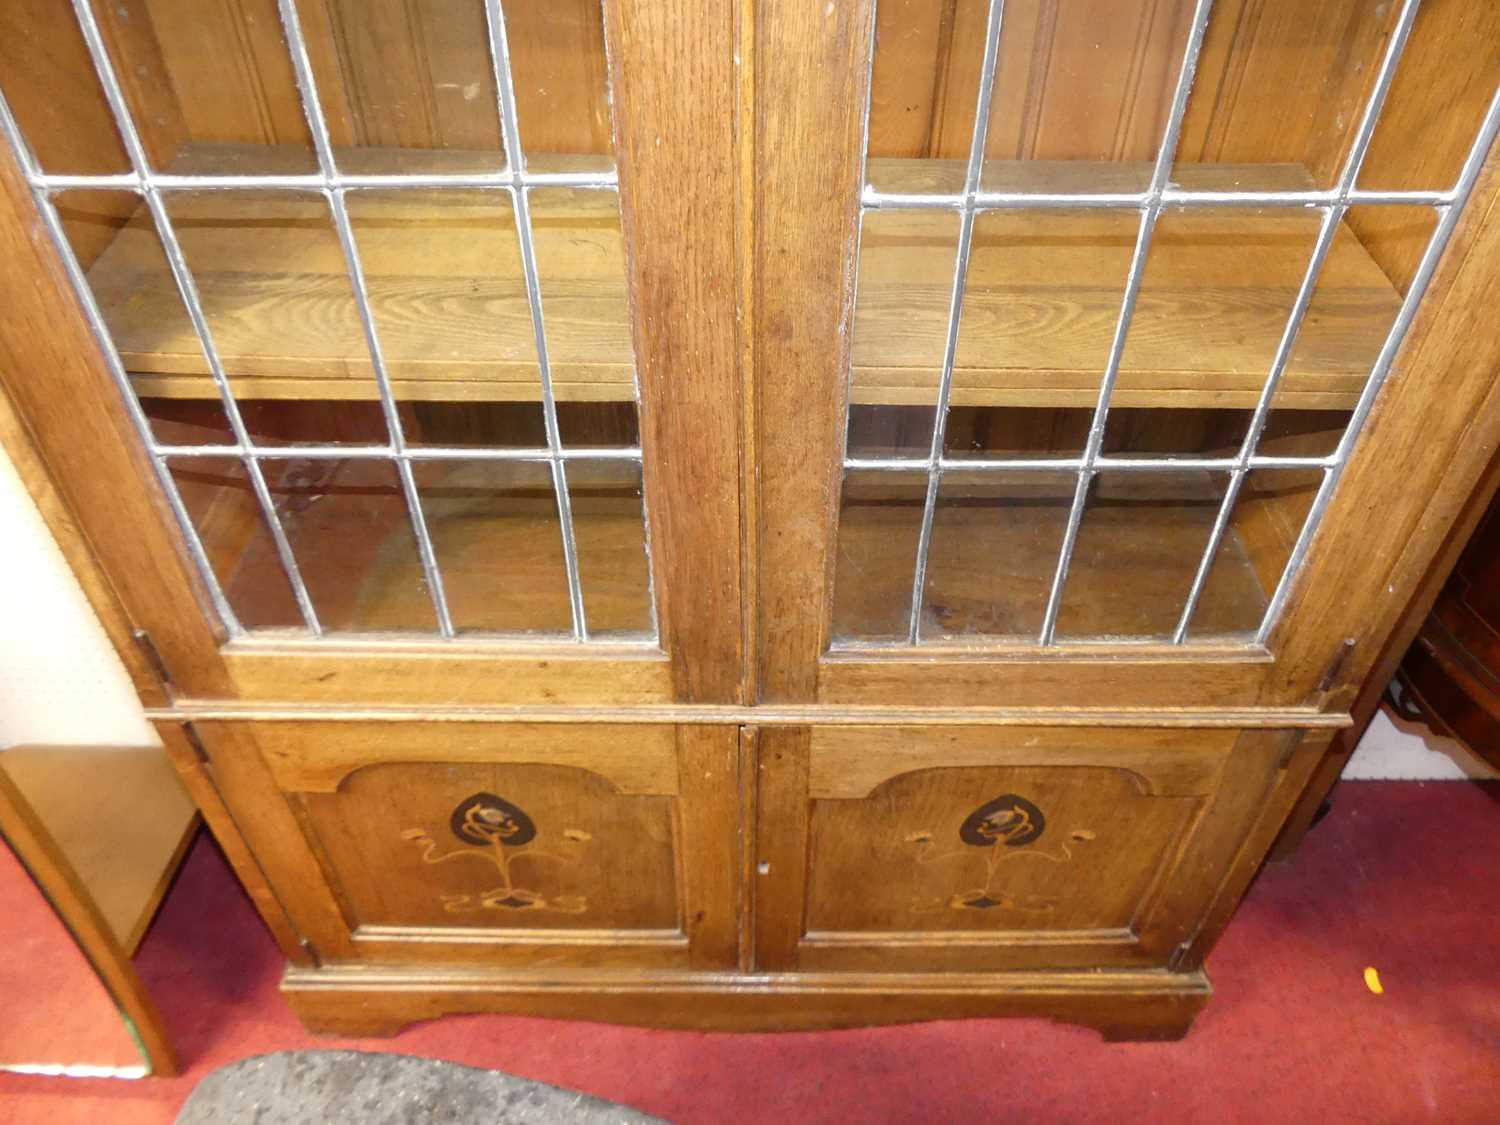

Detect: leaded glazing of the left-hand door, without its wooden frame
[0, 0, 657, 642]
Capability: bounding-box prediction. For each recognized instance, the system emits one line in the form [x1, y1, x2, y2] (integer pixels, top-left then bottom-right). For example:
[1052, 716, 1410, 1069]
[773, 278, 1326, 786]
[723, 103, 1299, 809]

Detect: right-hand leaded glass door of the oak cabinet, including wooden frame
[758, 0, 1500, 707]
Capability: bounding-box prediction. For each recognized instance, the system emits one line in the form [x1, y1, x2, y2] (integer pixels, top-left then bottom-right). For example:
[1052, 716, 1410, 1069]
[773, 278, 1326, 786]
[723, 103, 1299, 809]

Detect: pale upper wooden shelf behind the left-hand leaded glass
[83, 147, 635, 402]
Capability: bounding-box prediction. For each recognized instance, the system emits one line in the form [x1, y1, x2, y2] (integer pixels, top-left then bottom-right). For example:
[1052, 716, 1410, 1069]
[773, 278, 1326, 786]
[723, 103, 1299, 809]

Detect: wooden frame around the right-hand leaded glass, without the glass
[747, 0, 1500, 714]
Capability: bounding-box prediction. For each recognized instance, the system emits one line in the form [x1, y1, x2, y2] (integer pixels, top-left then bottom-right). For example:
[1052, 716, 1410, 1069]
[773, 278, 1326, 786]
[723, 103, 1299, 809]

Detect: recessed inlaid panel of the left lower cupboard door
[302, 764, 680, 932]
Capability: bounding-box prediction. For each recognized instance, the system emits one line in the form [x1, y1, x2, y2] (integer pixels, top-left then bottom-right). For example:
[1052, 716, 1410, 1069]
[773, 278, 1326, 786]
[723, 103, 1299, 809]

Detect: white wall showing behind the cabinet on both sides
[0, 453, 1496, 779]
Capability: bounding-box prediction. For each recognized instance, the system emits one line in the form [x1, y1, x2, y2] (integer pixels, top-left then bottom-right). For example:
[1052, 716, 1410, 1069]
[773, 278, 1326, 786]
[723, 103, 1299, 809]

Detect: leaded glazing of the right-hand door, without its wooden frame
[831, 0, 1500, 648]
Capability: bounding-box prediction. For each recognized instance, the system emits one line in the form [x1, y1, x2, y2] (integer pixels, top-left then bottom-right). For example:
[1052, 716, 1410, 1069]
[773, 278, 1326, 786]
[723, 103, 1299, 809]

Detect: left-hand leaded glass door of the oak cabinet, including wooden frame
[0, 0, 738, 701]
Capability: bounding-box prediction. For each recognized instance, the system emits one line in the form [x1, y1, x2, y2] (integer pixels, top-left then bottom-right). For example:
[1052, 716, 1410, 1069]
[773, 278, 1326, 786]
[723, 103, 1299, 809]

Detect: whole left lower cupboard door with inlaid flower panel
[195, 723, 738, 968]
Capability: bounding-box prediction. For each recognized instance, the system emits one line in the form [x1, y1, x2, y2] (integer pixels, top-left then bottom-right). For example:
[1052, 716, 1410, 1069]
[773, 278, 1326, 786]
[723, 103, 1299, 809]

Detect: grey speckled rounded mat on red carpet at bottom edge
[177, 1050, 660, 1125]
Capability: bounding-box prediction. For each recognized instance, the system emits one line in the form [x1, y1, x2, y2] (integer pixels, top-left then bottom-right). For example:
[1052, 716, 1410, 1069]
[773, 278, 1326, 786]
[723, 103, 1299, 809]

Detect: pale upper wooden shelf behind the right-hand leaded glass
[852, 161, 1400, 410]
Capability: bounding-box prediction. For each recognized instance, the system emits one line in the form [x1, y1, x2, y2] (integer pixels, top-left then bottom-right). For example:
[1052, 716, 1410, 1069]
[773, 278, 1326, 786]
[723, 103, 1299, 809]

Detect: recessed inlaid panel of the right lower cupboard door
[807, 767, 1202, 938]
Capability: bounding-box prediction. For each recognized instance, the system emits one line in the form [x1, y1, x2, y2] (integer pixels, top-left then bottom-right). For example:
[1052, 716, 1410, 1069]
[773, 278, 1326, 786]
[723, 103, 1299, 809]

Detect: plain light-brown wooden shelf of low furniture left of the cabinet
[0, 746, 198, 956]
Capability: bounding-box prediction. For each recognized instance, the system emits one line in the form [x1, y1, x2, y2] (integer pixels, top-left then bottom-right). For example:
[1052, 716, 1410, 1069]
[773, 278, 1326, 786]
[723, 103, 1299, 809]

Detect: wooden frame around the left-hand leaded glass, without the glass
[0, 0, 744, 707]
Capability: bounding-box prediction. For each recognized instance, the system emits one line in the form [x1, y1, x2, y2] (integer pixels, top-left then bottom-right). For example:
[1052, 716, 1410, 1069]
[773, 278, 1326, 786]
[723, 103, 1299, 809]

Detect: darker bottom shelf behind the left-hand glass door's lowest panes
[177, 459, 651, 638]
